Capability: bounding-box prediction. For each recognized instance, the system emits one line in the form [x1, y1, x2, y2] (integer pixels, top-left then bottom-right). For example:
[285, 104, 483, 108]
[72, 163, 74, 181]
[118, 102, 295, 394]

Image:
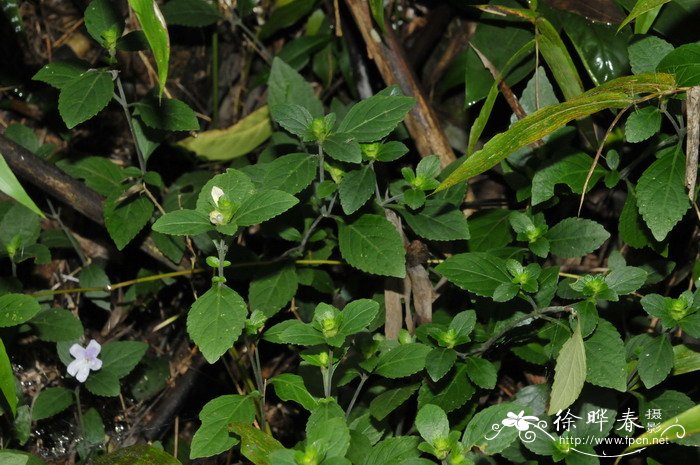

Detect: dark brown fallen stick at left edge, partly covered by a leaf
[0, 135, 182, 270]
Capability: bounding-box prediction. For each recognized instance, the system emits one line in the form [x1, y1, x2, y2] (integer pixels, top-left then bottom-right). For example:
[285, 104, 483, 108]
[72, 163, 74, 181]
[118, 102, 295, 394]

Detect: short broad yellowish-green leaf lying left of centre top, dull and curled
[178, 106, 270, 161]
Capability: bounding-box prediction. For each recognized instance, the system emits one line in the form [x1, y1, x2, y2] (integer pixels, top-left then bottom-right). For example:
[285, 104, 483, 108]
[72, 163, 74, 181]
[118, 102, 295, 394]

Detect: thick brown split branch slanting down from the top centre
[345, 0, 455, 167]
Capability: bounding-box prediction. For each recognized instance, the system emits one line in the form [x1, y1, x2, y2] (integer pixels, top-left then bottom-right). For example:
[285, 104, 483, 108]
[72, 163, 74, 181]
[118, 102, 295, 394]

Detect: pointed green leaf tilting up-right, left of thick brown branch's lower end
[338, 94, 415, 142]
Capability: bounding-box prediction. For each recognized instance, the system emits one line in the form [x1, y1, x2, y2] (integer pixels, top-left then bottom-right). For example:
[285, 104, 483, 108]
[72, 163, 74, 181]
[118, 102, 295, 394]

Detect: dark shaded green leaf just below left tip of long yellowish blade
[395, 200, 469, 241]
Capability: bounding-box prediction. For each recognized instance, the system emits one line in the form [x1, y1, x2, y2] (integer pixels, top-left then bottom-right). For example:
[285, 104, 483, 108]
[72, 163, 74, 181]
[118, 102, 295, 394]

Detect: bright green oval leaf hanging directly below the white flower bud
[187, 285, 248, 363]
